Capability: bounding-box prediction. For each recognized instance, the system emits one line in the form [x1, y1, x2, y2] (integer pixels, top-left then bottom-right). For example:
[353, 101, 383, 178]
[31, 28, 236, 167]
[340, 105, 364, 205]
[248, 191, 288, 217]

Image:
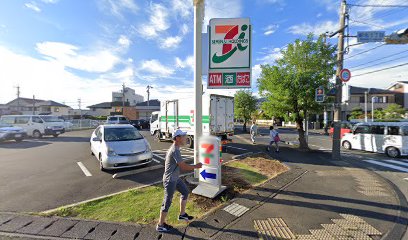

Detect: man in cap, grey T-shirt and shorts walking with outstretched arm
[156, 129, 202, 232]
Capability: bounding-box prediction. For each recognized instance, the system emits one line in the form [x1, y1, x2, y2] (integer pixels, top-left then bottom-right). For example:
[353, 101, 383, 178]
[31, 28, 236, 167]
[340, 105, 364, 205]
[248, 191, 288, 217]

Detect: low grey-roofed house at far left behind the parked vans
[5, 97, 72, 116]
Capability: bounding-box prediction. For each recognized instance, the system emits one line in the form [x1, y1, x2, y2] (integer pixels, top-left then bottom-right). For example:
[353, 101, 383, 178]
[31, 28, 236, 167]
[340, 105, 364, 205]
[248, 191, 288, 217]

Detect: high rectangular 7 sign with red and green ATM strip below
[207, 18, 251, 88]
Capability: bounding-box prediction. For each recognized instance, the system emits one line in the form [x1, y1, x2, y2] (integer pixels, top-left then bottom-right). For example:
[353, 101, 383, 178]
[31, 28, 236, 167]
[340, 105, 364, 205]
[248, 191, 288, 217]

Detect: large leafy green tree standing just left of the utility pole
[258, 34, 336, 149]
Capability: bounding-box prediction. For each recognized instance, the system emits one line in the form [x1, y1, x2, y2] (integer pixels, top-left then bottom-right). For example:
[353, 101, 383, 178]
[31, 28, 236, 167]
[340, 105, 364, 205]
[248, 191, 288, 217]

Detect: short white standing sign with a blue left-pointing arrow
[193, 136, 226, 198]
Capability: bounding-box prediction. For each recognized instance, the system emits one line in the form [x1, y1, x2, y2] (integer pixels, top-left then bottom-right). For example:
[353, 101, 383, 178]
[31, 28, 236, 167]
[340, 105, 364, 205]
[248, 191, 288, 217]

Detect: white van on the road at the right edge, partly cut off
[341, 122, 408, 157]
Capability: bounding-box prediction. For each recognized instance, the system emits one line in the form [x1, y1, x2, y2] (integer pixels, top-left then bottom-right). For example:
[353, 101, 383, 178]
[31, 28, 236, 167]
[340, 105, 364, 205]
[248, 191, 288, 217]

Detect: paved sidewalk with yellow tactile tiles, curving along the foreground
[0, 145, 407, 240]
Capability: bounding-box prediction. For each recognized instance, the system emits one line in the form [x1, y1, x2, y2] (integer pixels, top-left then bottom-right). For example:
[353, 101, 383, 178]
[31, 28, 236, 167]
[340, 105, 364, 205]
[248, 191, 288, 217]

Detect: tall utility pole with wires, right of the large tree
[332, 0, 347, 160]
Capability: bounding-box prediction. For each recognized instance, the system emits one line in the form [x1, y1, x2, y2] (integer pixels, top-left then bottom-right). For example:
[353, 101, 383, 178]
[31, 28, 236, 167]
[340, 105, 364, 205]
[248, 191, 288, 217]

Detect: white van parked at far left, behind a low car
[0, 115, 65, 138]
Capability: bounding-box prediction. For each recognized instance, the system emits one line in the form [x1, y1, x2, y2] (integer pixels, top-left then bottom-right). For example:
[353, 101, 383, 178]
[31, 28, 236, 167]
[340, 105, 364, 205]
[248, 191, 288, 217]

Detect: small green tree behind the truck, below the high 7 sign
[234, 90, 256, 132]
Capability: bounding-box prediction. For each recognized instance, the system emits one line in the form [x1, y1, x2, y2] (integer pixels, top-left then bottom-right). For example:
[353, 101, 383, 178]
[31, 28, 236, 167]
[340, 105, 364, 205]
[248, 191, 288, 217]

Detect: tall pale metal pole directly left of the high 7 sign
[193, 0, 204, 178]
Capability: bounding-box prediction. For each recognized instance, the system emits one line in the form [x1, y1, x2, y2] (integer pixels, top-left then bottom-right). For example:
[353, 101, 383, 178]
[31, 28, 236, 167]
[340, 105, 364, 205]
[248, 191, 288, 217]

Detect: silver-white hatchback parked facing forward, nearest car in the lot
[91, 124, 153, 171]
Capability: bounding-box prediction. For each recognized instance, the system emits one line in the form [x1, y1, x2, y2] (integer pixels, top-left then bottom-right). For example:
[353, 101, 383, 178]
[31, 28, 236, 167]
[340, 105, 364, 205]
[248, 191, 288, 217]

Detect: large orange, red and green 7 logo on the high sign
[212, 24, 248, 63]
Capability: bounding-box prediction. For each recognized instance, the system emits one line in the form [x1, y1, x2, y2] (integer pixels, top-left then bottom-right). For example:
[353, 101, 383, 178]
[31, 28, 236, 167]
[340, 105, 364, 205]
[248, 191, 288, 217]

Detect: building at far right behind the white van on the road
[342, 86, 404, 119]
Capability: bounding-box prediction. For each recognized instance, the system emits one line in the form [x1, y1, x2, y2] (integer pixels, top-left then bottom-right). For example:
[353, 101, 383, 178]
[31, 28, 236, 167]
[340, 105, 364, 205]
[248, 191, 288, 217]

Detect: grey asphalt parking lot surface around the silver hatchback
[0, 130, 236, 212]
